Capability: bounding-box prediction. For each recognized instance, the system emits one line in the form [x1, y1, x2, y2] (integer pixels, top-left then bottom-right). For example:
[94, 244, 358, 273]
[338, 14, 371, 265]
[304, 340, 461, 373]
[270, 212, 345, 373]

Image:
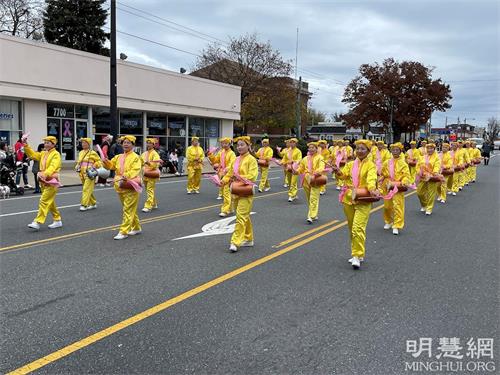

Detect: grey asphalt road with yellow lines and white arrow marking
[0, 164, 500, 374]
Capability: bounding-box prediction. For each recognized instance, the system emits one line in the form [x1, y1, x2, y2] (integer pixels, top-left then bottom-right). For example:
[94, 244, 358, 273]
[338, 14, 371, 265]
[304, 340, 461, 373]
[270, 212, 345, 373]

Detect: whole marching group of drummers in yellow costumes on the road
[22, 135, 481, 269]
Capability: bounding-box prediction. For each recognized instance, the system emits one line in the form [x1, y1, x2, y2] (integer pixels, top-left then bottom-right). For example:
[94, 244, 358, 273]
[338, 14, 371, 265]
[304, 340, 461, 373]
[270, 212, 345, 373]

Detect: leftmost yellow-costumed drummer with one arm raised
[22, 136, 62, 230]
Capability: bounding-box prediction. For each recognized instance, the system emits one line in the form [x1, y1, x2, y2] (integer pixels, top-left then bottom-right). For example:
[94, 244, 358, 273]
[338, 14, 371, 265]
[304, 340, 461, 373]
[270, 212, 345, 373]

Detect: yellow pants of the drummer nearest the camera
[344, 203, 372, 258]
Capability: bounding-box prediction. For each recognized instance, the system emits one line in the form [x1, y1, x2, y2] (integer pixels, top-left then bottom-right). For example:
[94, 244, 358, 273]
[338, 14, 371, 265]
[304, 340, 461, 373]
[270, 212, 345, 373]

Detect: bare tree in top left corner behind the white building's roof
[0, 0, 44, 40]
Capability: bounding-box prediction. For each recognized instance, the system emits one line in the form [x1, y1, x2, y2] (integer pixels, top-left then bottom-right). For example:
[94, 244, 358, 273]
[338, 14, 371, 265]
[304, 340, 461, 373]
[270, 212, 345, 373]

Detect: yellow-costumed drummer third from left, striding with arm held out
[103, 135, 142, 240]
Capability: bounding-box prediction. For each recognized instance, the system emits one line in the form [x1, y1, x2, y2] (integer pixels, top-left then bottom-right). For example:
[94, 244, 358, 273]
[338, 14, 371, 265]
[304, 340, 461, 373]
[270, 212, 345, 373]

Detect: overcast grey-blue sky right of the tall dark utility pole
[111, 0, 500, 127]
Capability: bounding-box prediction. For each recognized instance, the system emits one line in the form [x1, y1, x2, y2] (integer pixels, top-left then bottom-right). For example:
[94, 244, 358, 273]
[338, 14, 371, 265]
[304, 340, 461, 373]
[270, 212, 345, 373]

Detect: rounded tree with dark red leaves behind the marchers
[342, 58, 452, 142]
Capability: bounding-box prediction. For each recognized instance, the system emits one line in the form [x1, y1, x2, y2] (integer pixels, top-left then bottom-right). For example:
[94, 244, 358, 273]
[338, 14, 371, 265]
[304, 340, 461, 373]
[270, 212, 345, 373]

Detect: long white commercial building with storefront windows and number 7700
[0, 34, 241, 160]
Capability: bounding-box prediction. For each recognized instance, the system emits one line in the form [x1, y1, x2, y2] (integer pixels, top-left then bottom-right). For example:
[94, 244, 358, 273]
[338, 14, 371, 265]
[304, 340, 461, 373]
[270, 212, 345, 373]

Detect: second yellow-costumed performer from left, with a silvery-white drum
[75, 138, 102, 211]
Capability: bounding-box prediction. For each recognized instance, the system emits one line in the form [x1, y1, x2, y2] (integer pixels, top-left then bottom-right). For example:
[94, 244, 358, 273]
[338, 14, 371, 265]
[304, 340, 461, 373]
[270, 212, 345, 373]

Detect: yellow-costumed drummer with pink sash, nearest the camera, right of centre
[333, 139, 380, 269]
